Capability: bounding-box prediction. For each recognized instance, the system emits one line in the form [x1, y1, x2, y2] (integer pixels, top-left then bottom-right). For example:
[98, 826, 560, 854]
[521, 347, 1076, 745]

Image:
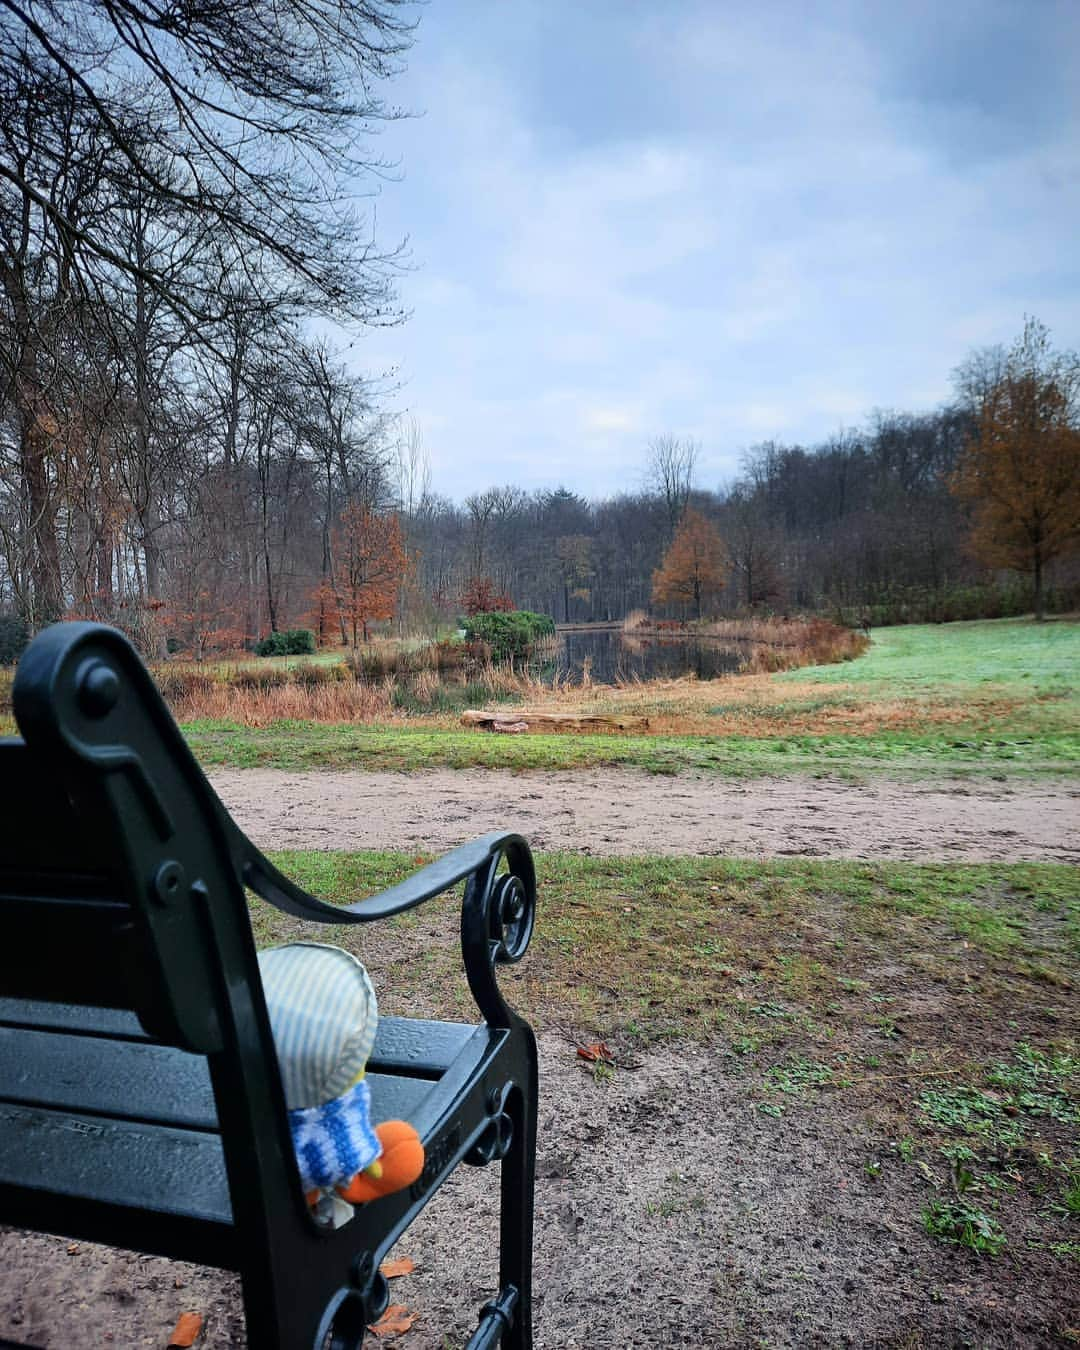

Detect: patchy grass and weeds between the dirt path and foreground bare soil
[255, 853, 1080, 1262]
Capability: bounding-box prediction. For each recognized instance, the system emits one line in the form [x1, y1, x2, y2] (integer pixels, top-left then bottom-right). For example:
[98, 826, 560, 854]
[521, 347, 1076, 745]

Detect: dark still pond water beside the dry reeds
[539, 629, 747, 684]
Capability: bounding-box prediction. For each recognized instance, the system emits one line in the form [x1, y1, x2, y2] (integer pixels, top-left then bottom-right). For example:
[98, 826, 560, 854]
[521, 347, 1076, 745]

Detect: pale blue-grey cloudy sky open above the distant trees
[351, 0, 1080, 498]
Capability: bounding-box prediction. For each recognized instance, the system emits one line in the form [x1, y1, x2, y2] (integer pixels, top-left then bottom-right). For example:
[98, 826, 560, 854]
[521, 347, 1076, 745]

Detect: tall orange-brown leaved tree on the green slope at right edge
[952, 319, 1080, 618]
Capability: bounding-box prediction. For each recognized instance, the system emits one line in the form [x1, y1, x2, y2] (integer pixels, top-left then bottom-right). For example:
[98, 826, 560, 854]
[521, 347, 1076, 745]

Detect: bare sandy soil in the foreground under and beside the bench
[0, 1033, 1080, 1350]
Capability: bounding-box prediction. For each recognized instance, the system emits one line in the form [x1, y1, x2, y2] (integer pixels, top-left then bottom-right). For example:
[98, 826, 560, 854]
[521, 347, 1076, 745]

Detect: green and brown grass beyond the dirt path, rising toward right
[188, 620, 1080, 778]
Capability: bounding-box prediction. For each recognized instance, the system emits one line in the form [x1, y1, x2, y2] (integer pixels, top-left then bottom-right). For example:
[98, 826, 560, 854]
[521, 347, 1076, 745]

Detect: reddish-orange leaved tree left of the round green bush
[326, 502, 406, 649]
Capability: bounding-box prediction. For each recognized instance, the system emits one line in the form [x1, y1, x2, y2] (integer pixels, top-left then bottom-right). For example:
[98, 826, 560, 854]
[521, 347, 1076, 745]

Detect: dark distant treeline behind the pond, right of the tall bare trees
[409, 408, 1080, 624]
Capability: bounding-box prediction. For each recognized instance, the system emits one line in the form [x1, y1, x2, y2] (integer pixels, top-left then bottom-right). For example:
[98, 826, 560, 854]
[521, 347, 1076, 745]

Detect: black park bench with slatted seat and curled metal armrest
[0, 624, 537, 1350]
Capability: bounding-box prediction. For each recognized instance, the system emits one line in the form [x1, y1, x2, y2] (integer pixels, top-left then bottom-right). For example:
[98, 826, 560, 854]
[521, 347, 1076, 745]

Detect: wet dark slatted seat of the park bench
[0, 999, 500, 1269]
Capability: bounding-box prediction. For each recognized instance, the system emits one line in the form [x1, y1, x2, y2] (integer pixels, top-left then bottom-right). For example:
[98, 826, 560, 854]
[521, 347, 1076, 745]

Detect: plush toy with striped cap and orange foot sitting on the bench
[259, 942, 424, 1223]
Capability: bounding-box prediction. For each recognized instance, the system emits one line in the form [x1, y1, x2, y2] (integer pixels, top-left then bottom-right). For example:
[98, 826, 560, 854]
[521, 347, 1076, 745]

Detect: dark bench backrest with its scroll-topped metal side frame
[0, 624, 311, 1278]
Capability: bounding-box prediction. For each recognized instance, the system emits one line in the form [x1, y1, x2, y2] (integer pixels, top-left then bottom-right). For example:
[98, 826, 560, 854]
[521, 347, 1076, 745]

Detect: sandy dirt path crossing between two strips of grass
[211, 770, 1080, 863]
